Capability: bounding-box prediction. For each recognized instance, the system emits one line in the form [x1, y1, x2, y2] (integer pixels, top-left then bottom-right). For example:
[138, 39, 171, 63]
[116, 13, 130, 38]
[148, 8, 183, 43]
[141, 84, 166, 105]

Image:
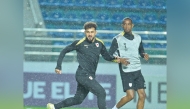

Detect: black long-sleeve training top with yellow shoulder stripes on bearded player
[56, 38, 116, 75]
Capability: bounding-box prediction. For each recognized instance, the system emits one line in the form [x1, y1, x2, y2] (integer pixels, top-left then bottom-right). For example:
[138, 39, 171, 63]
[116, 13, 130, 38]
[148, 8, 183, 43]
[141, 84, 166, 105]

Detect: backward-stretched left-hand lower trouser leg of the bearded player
[54, 83, 89, 109]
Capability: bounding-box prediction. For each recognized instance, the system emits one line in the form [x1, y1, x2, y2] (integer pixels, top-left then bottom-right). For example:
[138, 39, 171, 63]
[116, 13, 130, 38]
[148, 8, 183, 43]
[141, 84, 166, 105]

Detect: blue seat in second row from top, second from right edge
[144, 14, 158, 24]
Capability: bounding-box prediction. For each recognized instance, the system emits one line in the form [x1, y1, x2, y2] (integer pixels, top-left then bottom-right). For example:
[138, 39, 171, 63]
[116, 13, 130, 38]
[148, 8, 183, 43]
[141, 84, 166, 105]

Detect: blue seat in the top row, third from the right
[122, 0, 137, 8]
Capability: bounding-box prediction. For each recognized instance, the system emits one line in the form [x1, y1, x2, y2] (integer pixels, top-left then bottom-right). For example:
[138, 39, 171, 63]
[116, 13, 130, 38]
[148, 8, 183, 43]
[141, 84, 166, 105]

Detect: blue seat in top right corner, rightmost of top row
[153, 0, 166, 9]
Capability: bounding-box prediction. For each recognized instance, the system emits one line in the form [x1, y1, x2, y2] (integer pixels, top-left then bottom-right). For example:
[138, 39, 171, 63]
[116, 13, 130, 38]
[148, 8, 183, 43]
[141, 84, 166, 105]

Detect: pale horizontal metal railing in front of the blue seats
[23, 28, 167, 58]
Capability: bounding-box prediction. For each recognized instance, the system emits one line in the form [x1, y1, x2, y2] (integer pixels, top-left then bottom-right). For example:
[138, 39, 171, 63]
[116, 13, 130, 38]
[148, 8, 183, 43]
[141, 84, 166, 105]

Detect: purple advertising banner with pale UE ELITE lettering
[23, 72, 116, 108]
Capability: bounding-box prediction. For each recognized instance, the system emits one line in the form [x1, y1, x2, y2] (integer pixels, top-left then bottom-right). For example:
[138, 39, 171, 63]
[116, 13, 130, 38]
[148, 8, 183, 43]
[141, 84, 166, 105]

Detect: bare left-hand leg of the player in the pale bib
[116, 89, 135, 108]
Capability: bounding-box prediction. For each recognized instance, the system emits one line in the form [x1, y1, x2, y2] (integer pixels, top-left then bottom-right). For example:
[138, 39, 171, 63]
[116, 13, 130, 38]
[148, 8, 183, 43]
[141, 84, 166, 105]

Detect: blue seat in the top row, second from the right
[138, 0, 152, 9]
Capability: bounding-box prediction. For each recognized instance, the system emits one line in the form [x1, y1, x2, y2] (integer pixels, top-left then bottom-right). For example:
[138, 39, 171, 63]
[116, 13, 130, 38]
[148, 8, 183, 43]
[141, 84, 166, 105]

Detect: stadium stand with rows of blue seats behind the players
[23, 0, 167, 61]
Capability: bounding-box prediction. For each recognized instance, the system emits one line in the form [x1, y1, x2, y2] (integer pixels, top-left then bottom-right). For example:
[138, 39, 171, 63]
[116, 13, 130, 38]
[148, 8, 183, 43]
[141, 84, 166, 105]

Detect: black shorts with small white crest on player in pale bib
[120, 70, 146, 92]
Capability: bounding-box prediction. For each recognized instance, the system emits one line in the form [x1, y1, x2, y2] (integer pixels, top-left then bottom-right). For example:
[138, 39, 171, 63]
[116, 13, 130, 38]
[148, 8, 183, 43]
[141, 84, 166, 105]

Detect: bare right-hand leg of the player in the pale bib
[137, 89, 146, 109]
